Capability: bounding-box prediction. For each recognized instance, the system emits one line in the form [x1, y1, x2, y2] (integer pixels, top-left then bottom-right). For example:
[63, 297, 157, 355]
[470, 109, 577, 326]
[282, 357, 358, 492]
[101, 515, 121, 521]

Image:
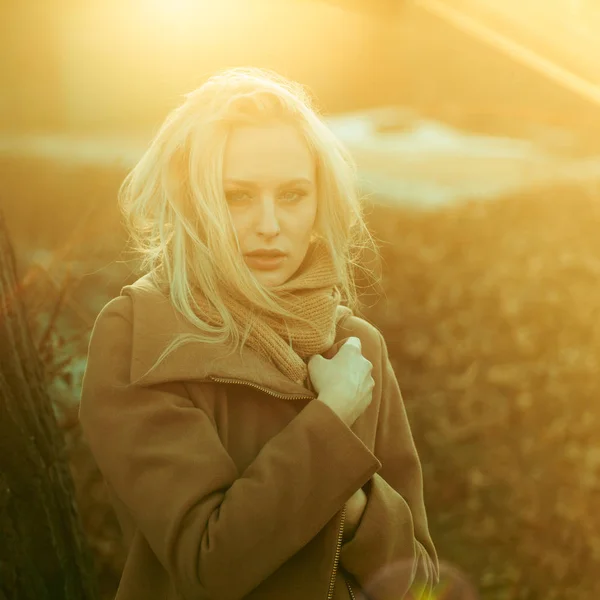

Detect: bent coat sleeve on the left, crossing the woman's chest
[79, 297, 381, 600]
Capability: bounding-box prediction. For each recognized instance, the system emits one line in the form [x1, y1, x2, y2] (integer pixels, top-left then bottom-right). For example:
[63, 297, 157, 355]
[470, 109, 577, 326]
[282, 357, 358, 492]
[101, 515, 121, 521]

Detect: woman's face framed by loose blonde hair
[223, 122, 317, 287]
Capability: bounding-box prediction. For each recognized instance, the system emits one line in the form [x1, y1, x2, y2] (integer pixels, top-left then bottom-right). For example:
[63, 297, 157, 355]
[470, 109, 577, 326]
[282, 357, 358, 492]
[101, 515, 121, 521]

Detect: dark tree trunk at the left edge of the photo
[0, 213, 97, 600]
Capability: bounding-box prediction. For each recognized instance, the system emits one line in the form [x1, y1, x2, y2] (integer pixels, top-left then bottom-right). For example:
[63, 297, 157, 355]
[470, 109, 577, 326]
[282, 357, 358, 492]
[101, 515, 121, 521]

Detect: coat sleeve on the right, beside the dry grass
[340, 333, 439, 600]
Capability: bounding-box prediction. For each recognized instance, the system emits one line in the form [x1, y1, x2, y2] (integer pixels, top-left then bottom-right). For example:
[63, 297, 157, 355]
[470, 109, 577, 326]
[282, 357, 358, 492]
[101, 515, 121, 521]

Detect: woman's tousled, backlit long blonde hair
[119, 67, 378, 364]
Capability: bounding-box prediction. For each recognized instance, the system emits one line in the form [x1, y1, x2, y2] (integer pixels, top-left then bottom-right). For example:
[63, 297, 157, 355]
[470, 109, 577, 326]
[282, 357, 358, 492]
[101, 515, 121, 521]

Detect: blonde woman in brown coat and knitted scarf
[80, 68, 438, 600]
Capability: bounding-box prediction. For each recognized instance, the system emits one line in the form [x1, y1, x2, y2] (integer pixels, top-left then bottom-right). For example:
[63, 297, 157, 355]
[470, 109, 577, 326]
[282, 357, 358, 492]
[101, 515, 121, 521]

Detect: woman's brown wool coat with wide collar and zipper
[79, 276, 438, 600]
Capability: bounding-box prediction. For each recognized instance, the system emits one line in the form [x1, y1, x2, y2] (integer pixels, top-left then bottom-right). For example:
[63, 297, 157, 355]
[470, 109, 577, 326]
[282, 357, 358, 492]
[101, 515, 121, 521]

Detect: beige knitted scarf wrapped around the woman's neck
[197, 240, 352, 383]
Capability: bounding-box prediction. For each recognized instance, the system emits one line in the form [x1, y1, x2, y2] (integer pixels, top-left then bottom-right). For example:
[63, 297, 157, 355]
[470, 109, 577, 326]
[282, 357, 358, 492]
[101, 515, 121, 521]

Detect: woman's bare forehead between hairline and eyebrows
[223, 122, 315, 185]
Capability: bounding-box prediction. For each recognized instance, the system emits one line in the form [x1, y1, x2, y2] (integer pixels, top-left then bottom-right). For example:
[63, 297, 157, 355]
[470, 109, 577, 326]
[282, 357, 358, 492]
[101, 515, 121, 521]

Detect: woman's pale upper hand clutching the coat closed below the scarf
[308, 337, 375, 427]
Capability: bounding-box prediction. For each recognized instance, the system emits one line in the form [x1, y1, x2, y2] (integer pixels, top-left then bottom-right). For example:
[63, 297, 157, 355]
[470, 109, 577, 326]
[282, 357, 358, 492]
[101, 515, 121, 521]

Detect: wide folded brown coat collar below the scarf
[121, 275, 347, 398]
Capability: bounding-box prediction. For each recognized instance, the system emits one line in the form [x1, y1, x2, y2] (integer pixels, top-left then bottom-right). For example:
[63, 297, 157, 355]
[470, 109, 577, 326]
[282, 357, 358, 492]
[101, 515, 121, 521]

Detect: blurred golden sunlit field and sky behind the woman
[0, 0, 600, 600]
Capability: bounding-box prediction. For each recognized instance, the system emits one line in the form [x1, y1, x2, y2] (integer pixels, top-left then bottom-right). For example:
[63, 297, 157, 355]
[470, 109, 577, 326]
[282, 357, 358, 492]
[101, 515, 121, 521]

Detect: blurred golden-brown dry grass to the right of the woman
[370, 183, 600, 600]
